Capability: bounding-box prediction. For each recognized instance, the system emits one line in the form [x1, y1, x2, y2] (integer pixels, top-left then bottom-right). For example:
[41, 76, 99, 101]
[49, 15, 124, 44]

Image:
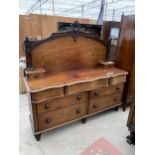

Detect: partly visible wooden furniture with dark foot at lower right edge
[127, 96, 135, 144]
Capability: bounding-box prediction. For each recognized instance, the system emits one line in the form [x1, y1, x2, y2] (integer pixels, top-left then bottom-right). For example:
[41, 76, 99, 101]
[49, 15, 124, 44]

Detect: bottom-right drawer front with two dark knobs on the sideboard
[89, 93, 122, 113]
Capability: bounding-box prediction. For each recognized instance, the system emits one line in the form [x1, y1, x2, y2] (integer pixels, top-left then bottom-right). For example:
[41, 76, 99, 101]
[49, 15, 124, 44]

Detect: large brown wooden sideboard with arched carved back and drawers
[24, 23, 127, 140]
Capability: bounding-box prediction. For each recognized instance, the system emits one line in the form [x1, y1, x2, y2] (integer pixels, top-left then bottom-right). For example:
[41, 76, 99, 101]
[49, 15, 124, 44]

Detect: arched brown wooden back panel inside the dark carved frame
[31, 36, 106, 73]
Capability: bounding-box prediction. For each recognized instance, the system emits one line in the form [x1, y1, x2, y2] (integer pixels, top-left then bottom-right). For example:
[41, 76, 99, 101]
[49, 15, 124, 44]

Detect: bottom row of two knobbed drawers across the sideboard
[38, 93, 122, 130]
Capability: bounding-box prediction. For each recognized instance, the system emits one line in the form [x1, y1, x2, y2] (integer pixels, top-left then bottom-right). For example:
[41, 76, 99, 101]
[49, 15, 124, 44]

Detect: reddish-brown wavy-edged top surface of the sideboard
[25, 67, 127, 92]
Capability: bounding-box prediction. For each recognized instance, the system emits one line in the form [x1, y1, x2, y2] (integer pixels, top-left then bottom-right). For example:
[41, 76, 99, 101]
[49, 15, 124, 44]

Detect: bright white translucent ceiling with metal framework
[19, 0, 135, 21]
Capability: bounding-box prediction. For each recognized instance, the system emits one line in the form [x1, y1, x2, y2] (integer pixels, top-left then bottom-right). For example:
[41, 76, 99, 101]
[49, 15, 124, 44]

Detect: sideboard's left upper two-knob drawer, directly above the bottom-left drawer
[37, 93, 88, 113]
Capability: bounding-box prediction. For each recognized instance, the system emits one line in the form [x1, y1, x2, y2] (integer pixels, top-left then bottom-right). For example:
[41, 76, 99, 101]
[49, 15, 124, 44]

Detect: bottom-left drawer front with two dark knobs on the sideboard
[38, 103, 86, 131]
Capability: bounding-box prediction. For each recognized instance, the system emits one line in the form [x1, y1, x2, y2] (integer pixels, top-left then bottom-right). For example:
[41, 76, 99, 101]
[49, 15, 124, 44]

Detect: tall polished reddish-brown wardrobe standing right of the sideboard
[116, 15, 135, 110]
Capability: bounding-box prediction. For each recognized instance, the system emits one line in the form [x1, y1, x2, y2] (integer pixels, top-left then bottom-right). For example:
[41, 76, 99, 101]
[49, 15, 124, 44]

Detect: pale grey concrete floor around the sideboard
[19, 95, 135, 155]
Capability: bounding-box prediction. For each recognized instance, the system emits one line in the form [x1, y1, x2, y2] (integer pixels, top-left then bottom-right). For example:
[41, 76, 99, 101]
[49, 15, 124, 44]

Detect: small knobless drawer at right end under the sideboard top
[109, 75, 126, 85]
